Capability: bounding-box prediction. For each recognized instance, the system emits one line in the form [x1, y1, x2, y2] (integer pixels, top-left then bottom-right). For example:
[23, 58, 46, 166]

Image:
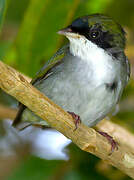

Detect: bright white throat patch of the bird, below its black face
[68, 36, 116, 83]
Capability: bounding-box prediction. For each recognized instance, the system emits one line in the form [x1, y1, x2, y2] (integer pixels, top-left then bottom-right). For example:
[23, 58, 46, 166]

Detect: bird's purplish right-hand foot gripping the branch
[97, 131, 118, 155]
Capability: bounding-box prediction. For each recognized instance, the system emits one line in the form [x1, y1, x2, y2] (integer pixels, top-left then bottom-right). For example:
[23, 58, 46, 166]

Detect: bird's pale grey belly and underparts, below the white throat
[22, 52, 122, 126]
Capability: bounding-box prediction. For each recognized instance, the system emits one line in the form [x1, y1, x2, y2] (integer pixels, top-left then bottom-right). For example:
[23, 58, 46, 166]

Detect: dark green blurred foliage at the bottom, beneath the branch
[8, 145, 107, 180]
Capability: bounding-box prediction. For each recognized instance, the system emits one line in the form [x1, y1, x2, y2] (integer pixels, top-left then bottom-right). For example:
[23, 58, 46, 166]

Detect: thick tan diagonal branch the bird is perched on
[0, 62, 134, 178]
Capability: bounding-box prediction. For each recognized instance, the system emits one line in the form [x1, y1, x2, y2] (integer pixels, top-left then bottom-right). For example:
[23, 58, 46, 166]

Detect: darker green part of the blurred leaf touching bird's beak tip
[28, 0, 79, 75]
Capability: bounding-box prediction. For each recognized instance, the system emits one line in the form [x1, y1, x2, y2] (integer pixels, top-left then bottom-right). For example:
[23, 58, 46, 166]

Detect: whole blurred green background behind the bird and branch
[0, 0, 134, 180]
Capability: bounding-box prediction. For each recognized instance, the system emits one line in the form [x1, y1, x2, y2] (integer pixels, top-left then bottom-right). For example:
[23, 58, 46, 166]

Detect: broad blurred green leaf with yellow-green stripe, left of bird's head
[7, 0, 80, 75]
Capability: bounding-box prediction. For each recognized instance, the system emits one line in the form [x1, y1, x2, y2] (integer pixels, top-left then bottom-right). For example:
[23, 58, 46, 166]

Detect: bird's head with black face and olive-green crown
[58, 14, 125, 49]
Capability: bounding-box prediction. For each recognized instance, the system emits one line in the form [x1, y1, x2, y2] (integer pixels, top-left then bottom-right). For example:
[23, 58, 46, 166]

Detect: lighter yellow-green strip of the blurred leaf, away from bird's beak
[14, 0, 48, 72]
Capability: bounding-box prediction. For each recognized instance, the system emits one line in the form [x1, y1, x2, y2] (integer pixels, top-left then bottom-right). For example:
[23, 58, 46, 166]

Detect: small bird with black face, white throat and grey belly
[13, 14, 130, 150]
